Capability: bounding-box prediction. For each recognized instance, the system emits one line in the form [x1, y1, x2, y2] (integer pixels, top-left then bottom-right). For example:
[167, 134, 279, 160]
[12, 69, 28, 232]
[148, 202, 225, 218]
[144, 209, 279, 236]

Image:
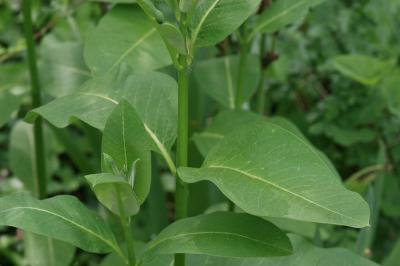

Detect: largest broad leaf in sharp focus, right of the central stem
[178, 122, 369, 228]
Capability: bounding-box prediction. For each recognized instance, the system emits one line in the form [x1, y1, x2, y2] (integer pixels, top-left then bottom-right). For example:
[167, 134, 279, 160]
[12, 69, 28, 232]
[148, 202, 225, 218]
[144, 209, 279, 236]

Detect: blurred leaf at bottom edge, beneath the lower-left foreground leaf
[24, 232, 75, 266]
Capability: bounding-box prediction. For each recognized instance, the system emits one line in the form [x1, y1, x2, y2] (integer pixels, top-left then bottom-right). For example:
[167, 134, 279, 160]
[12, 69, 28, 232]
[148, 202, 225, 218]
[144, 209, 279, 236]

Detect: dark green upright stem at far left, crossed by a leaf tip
[23, 0, 47, 199]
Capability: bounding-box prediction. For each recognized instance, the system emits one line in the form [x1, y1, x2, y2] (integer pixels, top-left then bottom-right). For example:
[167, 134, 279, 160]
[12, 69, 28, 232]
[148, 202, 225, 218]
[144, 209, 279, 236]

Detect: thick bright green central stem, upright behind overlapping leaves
[175, 55, 189, 266]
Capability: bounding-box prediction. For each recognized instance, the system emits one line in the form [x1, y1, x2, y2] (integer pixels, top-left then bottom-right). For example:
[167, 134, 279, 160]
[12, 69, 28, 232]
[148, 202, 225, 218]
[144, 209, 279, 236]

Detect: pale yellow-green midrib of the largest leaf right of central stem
[204, 165, 360, 224]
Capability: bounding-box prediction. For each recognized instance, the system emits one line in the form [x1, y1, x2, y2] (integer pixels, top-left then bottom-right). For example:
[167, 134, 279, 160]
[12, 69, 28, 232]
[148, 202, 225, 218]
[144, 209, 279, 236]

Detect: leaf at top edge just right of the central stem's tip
[189, 0, 260, 47]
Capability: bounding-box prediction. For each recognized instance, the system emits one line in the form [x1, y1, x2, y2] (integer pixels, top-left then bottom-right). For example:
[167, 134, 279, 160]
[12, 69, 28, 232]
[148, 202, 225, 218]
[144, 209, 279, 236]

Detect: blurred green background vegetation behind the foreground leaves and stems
[0, 0, 400, 266]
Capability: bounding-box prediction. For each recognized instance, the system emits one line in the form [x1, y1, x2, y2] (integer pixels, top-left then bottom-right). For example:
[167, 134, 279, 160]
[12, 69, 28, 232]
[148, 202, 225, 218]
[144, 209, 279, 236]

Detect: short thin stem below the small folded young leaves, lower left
[115, 186, 136, 266]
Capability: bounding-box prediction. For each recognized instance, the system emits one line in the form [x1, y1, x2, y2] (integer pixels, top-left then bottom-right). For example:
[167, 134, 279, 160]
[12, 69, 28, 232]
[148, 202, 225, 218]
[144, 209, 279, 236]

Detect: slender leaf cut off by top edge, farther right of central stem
[250, 0, 324, 38]
